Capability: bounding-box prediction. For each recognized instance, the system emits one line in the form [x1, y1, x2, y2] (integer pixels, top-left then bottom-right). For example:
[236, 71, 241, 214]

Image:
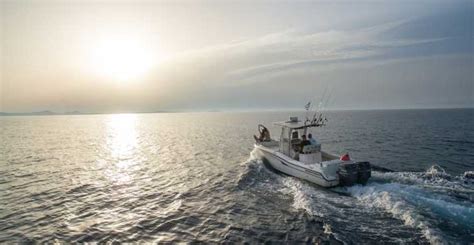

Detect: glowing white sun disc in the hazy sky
[92, 40, 153, 82]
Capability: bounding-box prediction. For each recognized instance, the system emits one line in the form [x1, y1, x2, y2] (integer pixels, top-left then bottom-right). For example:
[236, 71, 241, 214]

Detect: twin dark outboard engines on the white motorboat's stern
[338, 162, 371, 186]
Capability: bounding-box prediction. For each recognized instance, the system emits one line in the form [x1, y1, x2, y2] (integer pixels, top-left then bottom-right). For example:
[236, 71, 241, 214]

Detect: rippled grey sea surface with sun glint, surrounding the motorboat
[0, 109, 474, 244]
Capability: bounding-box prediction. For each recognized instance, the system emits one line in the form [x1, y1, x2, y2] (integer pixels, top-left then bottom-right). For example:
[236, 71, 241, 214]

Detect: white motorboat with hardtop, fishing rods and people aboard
[254, 116, 371, 187]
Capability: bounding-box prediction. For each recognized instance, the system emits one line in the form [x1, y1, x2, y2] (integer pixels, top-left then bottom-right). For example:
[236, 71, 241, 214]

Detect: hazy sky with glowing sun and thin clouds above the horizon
[0, 0, 474, 113]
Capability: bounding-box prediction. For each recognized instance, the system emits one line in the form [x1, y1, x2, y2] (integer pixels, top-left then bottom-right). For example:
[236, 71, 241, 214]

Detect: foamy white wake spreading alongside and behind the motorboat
[240, 153, 474, 244]
